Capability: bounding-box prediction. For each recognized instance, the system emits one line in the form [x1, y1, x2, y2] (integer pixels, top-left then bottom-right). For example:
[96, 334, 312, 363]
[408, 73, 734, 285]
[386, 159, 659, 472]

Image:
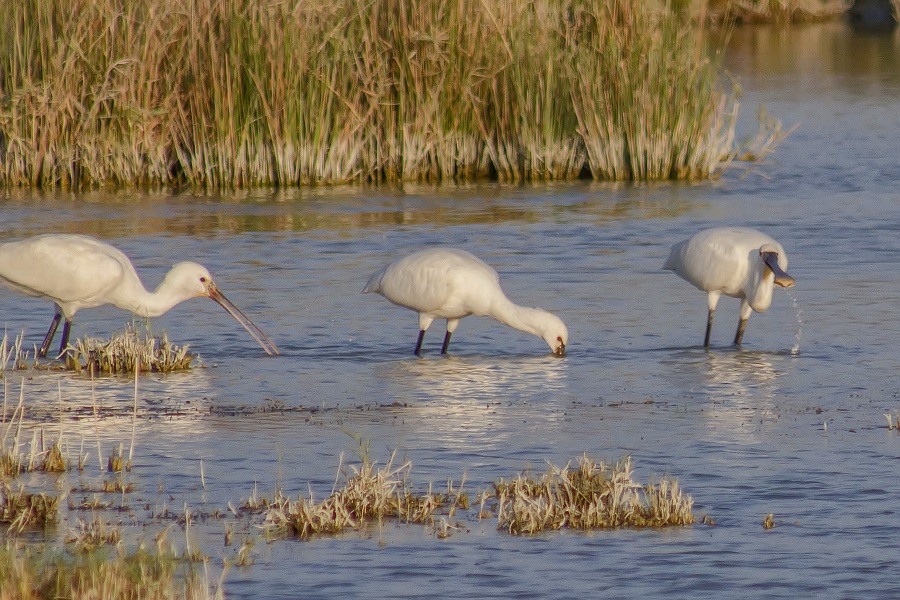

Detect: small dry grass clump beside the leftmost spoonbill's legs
[66, 325, 194, 375]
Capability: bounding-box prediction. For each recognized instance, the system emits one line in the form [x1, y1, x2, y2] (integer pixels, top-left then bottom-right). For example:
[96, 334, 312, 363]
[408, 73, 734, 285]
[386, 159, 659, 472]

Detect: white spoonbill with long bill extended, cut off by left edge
[0, 234, 278, 356]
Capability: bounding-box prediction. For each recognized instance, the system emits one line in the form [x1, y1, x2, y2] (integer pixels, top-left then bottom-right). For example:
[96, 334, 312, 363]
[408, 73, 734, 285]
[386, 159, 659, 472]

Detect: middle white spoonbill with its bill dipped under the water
[363, 248, 569, 356]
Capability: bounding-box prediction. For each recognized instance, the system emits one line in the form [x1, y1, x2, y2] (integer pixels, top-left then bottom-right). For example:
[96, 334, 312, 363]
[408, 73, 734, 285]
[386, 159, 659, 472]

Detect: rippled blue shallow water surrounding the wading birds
[0, 25, 900, 598]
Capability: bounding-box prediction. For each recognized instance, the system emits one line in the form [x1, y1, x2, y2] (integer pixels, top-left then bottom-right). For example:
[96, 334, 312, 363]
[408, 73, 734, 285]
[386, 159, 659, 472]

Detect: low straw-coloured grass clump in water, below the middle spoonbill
[264, 456, 468, 539]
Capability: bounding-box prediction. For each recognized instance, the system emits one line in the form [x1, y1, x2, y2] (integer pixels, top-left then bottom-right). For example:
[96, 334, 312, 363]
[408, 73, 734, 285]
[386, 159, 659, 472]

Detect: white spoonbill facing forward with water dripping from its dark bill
[663, 227, 794, 348]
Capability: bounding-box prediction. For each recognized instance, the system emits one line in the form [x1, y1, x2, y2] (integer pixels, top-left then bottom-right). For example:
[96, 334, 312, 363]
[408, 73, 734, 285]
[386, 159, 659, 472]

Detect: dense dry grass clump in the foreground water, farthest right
[495, 456, 694, 534]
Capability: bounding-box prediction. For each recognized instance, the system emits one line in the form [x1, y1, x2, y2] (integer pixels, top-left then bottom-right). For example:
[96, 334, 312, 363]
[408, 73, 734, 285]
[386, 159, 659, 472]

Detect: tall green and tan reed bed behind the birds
[0, 0, 779, 188]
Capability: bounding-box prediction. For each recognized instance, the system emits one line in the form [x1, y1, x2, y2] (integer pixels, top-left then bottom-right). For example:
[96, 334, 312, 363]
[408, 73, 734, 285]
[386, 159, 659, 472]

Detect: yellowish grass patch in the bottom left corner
[0, 542, 225, 600]
